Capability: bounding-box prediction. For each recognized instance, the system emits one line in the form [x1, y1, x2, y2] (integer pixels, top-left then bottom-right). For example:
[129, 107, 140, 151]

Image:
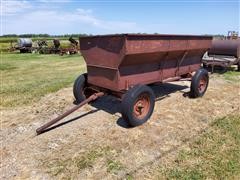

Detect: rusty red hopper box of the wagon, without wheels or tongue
[80, 34, 212, 92]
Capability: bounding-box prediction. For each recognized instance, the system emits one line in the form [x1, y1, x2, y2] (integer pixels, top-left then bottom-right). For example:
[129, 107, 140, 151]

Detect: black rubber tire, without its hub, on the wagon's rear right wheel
[190, 68, 209, 98]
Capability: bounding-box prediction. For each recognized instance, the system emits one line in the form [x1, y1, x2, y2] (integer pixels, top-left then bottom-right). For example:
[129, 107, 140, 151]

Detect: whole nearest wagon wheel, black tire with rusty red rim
[122, 85, 155, 127]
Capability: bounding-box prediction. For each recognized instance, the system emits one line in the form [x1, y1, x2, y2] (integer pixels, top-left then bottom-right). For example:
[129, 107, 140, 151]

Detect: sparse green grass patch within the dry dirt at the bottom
[40, 146, 125, 179]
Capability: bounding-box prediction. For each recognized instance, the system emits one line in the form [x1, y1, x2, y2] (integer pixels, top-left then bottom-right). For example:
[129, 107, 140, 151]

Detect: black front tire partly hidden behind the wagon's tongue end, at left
[73, 73, 87, 103]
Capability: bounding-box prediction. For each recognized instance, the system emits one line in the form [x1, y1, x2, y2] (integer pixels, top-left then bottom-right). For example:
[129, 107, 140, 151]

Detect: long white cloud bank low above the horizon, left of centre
[3, 5, 137, 34]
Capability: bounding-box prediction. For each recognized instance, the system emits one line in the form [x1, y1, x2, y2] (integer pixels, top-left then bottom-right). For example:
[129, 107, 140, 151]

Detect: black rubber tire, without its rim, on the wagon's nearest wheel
[122, 85, 155, 127]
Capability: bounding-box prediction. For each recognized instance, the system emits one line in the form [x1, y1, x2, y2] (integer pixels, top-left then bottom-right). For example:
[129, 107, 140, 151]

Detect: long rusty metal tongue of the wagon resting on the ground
[36, 92, 104, 134]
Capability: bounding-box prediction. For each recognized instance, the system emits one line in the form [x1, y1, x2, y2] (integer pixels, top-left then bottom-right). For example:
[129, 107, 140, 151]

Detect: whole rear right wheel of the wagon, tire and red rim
[190, 69, 209, 98]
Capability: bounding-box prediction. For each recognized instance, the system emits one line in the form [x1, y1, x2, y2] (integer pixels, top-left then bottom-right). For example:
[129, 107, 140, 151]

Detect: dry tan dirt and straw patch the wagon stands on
[0, 76, 240, 179]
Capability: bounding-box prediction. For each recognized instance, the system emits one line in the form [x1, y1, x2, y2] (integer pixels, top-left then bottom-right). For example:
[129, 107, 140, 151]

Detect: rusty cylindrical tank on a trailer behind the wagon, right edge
[203, 31, 240, 72]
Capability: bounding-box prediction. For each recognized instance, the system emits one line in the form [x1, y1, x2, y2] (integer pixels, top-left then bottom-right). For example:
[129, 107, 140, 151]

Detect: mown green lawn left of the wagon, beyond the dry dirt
[0, 53, 85, 107]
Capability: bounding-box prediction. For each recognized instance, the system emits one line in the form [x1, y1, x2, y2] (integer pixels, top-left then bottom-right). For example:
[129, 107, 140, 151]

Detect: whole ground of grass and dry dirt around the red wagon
[0, 53, 240, 179]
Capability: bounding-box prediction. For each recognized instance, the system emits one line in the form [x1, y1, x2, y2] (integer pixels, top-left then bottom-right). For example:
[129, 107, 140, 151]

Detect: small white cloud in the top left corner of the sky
[1, 0, 32, 16]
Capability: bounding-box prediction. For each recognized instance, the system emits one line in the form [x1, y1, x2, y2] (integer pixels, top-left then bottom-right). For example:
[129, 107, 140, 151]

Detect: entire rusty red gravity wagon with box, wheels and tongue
[35, 34, 212, 135]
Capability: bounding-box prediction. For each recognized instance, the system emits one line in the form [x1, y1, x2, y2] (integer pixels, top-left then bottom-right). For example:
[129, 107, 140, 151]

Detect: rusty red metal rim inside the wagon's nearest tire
[133, 93, 150, 119]
